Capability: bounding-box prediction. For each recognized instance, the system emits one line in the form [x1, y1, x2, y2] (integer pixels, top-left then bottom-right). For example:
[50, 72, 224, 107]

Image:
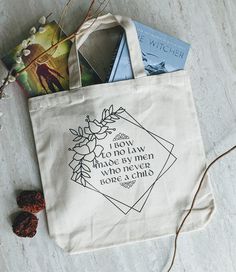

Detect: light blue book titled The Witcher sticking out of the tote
[108, 21, 190, 82]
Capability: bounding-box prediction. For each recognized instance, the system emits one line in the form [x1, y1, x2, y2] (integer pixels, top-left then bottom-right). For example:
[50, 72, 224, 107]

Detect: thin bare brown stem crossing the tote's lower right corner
[167, 145, 236, 272]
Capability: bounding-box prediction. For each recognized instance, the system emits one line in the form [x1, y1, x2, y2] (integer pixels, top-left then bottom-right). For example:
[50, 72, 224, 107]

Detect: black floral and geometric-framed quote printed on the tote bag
[69, 105, 177, 214]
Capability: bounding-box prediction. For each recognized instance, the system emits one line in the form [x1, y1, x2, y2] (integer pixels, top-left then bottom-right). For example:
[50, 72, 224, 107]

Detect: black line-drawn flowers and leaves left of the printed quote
[68, 105, 125, 187]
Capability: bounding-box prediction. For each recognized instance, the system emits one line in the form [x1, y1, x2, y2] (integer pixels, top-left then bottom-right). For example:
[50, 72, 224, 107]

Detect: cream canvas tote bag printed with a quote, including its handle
[29, 14, 214, 253]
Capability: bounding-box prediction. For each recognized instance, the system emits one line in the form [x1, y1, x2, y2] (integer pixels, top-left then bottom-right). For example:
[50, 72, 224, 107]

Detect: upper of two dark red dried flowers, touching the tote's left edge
[16, 191, 45, 213]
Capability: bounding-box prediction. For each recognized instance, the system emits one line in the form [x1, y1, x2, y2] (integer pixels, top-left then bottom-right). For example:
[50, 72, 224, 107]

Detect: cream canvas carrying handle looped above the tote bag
[68, 13, 146, 90]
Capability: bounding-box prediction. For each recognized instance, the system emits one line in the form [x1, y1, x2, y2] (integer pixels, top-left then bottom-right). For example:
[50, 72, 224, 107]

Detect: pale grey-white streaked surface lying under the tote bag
[0, 0, 236, 272]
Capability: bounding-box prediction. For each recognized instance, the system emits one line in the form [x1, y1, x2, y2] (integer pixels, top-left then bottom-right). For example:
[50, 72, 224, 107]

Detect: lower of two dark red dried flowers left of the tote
[12, 212, 38, 237]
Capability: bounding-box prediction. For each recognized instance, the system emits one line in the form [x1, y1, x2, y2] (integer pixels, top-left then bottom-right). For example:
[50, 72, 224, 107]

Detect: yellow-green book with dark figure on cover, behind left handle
[2, 21, 101, 97]
